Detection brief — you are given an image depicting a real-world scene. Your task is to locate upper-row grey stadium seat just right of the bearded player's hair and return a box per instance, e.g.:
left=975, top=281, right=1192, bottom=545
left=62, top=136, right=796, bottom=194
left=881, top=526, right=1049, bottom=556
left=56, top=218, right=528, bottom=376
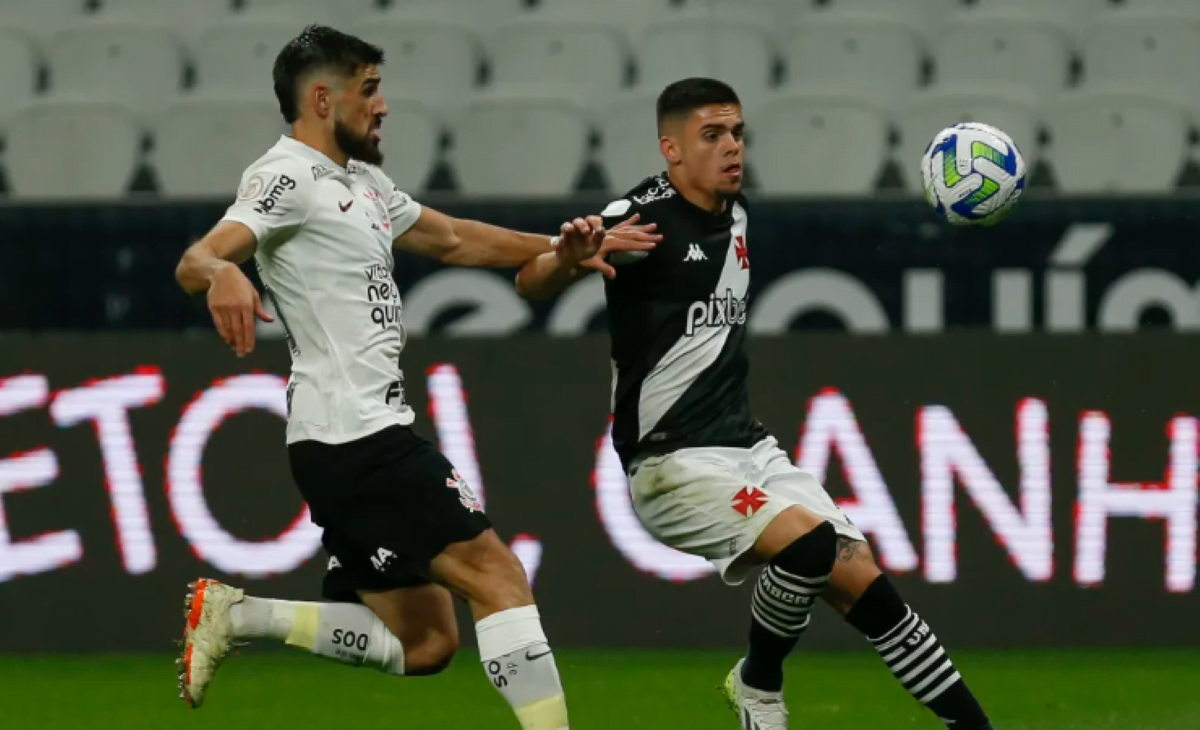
left=348, top=17, right=482, bottom=112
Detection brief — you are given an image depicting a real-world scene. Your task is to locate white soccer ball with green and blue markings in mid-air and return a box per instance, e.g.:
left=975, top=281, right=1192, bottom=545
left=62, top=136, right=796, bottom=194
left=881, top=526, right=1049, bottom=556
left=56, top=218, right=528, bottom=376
left=920, top=122, right=1025, bottom=226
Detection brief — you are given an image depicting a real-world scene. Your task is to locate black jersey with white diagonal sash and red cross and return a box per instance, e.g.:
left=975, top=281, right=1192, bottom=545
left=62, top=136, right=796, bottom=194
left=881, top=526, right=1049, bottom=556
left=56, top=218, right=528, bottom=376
left=602, top=174, right=767, bottom=469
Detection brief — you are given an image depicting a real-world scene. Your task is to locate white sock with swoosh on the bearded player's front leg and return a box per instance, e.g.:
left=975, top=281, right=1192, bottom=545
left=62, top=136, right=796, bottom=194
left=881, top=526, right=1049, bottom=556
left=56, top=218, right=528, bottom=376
left=475, top=606, right=569, bottom=730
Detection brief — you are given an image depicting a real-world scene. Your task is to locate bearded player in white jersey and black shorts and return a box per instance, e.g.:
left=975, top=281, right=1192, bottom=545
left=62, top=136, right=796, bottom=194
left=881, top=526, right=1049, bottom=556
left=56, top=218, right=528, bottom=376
left=169, top=26, right=655, bottom=730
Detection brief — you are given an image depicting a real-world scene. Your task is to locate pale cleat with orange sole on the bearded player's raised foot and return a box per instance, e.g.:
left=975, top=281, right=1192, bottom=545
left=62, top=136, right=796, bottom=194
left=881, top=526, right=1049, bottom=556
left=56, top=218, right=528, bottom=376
left=175, top=578, right=245, bottom=708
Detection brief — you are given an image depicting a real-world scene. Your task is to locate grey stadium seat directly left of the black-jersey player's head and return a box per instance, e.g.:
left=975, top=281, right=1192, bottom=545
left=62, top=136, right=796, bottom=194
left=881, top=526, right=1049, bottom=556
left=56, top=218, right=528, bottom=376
left=596, top=94, right=666, bottom=193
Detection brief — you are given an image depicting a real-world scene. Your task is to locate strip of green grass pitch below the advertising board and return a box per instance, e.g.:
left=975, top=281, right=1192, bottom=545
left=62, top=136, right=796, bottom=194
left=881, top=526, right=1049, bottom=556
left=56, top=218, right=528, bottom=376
left=0, top=650, right=1200, bottom=730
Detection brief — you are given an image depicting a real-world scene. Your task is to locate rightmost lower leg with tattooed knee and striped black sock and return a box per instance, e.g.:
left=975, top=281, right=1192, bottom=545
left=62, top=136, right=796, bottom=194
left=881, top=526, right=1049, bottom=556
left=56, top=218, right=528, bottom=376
left=827, top=540, right=991, bottom=730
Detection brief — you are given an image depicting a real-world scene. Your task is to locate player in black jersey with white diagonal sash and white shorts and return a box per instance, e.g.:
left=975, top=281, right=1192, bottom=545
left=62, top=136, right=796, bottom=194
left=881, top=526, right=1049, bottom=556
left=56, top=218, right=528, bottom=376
left=517, top=78, right=990, bottom=730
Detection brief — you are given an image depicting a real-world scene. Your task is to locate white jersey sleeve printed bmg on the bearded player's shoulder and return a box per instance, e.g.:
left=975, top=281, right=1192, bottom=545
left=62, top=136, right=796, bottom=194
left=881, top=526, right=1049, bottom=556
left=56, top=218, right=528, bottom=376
left=221, top=160, right=313, bottom=246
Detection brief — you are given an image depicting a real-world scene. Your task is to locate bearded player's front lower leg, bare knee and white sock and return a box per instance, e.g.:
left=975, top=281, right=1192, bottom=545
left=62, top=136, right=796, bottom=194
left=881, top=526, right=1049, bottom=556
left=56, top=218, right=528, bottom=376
left=432, top=529, right=569, bottom=730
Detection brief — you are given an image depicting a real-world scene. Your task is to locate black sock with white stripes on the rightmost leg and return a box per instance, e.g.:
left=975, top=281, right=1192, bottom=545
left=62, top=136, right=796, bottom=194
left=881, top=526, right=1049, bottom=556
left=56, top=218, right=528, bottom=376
left=846, top=575, right=990, bottom=730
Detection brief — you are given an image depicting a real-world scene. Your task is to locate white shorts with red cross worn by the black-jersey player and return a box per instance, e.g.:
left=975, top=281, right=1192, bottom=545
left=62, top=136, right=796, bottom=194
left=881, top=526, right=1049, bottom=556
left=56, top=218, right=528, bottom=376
left=630, top=437, right=865, bottom=585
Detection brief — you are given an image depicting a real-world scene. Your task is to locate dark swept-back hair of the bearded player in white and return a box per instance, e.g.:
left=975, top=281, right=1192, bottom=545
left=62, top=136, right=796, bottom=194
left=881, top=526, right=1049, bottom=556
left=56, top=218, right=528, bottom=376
left=271, top=25, right=384, bottom=124
